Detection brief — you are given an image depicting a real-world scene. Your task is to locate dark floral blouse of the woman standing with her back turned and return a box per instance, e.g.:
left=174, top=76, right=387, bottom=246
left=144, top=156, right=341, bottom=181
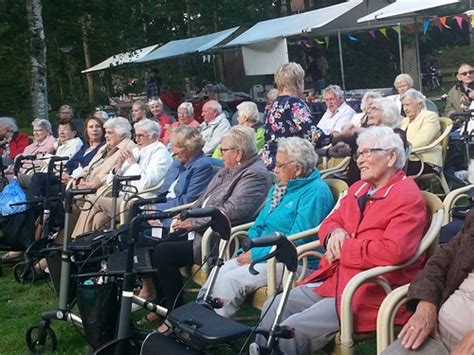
left=262, top=95, right=318, bottom=171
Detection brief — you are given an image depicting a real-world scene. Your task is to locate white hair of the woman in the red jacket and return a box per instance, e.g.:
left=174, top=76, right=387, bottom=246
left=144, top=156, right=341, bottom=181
left=357, top=126, right=406, bottom=170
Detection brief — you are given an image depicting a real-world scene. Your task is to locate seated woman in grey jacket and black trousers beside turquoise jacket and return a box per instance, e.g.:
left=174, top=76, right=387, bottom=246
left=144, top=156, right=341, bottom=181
left=152, top=126, right=272, bottom=310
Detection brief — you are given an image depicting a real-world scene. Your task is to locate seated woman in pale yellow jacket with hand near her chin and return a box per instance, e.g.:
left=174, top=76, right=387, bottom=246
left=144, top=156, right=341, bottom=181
left=401, top=89, right=443, bottom=175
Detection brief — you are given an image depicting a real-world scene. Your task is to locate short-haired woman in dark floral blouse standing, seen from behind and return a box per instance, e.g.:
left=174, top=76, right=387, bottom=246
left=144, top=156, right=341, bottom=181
left=262, top=62, right=316, bottom=171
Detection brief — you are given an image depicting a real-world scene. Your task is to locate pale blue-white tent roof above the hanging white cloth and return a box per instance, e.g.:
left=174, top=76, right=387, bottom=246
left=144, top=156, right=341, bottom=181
left=226, top=0, right=364, bottom=47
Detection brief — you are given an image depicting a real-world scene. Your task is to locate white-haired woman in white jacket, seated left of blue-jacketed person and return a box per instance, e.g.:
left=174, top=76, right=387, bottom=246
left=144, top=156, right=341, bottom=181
left=72, top=119, right=173, bottom=237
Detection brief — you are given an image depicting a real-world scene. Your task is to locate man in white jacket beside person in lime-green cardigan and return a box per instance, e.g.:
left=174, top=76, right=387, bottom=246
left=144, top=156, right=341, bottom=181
left=200, top=100, right=230, bottom=155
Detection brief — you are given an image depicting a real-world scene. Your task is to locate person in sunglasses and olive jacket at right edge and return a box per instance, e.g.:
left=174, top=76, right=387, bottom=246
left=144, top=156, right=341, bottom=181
left=444, top=63, right=474, bottom=117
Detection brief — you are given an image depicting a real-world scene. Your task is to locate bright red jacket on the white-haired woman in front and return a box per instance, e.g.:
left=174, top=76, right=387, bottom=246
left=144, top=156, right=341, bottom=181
left=303, top=171, right=429, bottom=332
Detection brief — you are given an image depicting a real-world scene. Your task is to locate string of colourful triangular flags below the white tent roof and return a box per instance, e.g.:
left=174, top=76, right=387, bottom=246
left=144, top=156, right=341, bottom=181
left=306, top=14, right=474, bottom=48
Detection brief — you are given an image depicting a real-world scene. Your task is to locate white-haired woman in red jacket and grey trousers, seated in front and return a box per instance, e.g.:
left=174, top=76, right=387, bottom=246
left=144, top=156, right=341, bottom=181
left=261, top=127, right=428, bottom=354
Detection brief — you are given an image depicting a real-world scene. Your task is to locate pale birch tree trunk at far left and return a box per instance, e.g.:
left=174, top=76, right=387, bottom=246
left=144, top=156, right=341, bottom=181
left=26, top=0, right=48, bottom=119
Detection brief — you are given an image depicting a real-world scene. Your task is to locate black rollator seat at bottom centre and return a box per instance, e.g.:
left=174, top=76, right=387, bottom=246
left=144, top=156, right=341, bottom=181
left=167, top=302, right=252, bottom=347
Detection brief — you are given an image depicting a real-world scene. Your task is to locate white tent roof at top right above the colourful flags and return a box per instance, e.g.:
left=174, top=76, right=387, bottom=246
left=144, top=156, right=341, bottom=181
left=357, top=0, right=462, bottom=23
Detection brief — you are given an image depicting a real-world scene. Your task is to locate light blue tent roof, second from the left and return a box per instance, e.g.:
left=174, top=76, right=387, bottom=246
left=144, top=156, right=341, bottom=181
left=135, top=27, right=239, bottom=63
